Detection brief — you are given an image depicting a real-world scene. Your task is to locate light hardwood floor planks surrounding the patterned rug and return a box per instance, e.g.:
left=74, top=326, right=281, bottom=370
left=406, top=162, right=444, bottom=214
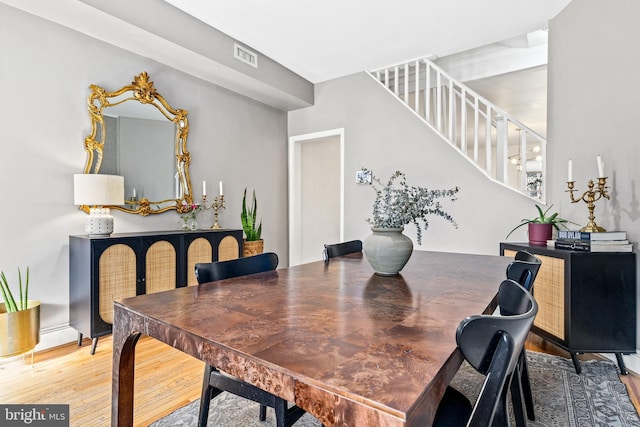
left=0, top=335, right=640, bottom=427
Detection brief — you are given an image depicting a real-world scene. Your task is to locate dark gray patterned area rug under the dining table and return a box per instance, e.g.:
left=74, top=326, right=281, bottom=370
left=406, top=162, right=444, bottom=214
left=152, top=351, right=640, bottom=427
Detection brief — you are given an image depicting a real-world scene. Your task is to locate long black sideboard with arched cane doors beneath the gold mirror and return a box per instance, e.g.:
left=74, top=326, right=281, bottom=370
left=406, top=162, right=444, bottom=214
left=69, top=230, right=242, bottom=354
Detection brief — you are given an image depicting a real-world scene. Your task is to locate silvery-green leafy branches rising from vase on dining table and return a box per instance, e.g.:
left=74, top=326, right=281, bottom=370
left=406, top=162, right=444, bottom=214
left=362, top=168, right=460, bottom=245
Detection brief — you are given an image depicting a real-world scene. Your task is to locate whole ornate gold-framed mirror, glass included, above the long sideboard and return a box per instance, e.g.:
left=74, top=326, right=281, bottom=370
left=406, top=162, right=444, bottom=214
left=83, top=72, right=192, bottom=216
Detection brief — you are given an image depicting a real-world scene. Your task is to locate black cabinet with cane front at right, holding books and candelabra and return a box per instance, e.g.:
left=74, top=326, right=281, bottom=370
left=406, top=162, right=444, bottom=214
left=500, top=243, right=636, bottom=373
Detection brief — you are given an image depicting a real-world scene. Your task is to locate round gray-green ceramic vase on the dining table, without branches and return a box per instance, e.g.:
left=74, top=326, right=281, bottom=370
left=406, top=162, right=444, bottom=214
left=362, top=227, right=413, bottom=276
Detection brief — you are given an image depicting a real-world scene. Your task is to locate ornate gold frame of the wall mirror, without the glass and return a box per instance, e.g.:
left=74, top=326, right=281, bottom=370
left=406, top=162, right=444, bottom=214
left=80, top=71, right=193, bottom=216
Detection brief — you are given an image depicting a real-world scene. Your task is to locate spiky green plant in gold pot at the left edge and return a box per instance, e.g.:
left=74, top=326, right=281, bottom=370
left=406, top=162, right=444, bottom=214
left=0, top=267, right=40, bottom=357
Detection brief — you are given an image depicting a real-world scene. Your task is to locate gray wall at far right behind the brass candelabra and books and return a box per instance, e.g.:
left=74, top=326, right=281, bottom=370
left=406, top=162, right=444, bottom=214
left=548, top=0, right=640, bottom=348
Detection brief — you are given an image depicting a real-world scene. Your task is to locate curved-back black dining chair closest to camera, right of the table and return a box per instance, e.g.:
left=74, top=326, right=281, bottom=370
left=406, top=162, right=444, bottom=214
left=433, top=279, right=538, bottom=427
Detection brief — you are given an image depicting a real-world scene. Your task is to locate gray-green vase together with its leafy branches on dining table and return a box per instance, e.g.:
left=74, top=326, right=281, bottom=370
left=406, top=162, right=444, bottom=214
left=362, top=168, right=459, bottom=276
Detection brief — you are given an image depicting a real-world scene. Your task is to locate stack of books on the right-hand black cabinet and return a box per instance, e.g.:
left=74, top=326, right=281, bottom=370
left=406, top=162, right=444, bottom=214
left=555, top=230, right=633, bottom=252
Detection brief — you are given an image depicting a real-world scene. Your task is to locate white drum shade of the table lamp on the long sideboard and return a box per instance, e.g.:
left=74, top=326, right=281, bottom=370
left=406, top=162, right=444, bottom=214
left=73, top=173, right=124, bottom=206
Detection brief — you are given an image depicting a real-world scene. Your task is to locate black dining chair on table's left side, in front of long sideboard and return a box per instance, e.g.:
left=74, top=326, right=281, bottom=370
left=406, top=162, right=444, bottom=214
left=195, top=252, right=305, bottom=427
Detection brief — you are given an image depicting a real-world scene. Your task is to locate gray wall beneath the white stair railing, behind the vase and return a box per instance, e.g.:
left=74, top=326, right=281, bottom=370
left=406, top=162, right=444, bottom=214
left=289, top=73, right=535, bottom=254
